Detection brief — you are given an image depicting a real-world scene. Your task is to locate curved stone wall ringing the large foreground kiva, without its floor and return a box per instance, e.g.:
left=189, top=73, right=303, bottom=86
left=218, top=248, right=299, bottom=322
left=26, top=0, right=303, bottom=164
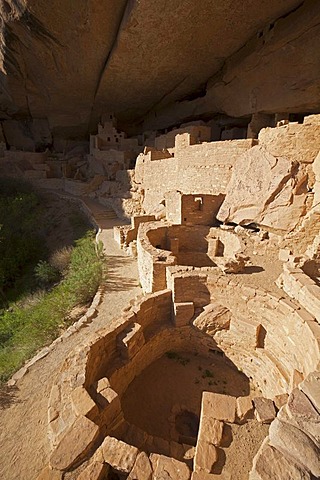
left=47, top=276, right=320, bottom=479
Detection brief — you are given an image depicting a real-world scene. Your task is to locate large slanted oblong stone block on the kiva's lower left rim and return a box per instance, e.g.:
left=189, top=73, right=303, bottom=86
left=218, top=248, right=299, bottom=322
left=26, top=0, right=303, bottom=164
left=50, top=416, right=99, bottom=471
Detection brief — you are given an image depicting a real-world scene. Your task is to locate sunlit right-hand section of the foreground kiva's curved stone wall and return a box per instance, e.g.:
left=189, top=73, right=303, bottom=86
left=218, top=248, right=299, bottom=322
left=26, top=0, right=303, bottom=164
left=167, top=267, right=320, bottom=398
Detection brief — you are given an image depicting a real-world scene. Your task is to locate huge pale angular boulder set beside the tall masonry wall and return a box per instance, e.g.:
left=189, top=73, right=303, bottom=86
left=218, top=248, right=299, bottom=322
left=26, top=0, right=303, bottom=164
left=217, top=146, right=306, bottom=231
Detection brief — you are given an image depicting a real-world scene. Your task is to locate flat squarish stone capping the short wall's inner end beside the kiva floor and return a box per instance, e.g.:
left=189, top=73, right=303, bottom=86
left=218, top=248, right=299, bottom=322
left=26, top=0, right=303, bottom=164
left=201, top=392, right=236, bottom=423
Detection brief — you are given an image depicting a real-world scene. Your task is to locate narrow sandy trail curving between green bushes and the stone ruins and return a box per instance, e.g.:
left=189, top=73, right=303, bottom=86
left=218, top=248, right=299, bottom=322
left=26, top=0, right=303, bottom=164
left=0, top=198, right=142, bottom=480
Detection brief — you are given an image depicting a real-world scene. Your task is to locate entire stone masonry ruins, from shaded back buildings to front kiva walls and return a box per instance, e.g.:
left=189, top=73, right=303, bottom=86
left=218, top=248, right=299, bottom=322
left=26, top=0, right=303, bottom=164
left=15, top=115, right=320, bottom=480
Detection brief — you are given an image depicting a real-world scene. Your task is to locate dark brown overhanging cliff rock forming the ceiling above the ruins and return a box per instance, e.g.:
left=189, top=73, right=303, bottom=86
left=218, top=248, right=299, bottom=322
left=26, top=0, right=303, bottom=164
left=0, top=0, right=320, bottom=144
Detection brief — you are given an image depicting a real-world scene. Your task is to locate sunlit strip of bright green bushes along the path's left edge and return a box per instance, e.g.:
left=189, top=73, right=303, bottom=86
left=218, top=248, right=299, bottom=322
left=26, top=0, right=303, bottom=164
left=0, top=232, right=102, bottom=381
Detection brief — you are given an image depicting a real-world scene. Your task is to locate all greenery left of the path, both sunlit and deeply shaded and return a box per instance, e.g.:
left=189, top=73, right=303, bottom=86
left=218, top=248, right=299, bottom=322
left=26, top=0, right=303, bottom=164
left=0, top=178, right=102, bottom=382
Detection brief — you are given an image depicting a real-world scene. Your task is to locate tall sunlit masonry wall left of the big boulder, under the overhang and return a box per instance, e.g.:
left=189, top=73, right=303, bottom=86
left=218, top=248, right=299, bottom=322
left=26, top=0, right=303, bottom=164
left=135, top=139, right=253, bottom=213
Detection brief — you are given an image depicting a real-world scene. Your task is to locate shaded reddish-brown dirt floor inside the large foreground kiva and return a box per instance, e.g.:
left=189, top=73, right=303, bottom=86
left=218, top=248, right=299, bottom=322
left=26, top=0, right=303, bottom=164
left=122, top=352, right=254, bottom=440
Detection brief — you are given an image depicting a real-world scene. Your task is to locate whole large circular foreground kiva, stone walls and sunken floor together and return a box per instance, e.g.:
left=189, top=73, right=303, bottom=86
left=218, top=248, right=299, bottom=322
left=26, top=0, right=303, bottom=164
left=48, top=267, right=320, bottom=480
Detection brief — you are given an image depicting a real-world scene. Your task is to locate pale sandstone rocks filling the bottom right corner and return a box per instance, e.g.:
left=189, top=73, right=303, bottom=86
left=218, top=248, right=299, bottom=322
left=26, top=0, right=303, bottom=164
left=249, top=371, right=320, bottom=480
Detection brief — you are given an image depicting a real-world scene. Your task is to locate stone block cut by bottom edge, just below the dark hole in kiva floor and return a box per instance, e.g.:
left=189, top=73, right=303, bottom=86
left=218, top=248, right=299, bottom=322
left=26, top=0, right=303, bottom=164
left=149, top=453, right=191, bottom=480
